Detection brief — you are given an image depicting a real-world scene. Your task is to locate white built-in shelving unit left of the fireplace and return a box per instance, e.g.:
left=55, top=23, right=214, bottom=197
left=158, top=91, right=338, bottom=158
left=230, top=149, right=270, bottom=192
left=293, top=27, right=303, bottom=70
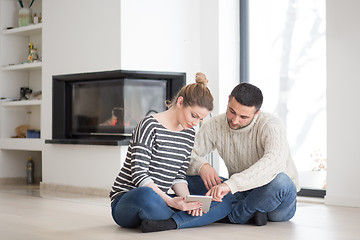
left=0, top=0, right=44, bottom=178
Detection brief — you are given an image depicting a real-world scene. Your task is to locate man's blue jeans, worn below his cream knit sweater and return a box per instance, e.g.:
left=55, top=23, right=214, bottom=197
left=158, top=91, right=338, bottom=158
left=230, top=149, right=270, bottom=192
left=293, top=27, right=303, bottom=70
left=187, top=173, right=297, bottom=224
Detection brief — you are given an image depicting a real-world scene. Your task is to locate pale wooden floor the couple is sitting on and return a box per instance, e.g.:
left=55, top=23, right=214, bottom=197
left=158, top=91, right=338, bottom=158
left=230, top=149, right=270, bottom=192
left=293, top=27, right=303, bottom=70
left=0, top=186, right=360, bottom=240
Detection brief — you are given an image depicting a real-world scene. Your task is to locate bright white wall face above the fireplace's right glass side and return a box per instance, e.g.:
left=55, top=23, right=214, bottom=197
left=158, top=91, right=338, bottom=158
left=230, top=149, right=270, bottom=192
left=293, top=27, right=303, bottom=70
left=121, top=0, right=201, bottom=75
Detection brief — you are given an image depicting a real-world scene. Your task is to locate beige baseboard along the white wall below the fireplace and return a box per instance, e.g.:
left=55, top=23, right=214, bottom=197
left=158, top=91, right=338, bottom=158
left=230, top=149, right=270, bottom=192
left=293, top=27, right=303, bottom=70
left=40, top=182, right=110, bottom=197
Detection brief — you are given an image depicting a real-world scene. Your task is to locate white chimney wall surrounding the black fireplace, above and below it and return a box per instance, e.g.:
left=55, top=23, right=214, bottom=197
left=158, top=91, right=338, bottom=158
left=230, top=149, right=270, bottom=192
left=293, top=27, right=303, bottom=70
left=42, top=0, right=238, bottom=189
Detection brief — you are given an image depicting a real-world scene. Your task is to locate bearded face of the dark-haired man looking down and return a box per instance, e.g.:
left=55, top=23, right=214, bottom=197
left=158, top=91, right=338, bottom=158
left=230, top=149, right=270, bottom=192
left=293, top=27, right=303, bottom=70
left=226, top=97, right=260, bottom=130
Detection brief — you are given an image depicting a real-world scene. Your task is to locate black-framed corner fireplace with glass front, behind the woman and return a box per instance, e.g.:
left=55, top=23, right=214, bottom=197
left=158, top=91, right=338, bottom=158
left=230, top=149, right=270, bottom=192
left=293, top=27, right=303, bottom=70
left=45, top=70, right=186, bottom=145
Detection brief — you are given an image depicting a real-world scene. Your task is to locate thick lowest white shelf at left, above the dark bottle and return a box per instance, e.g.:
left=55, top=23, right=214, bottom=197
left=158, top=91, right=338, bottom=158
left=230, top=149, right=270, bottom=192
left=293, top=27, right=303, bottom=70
left=0, top=138, right=44, bottom=151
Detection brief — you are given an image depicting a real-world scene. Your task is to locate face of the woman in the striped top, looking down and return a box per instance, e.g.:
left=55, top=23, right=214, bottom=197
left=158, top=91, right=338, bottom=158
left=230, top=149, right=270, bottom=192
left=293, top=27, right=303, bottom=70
left=178, top=96, right=210, bottom=129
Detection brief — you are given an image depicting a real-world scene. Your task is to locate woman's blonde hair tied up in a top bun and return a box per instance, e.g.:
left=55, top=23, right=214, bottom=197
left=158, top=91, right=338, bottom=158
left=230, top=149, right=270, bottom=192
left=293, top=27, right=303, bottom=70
left=167, top=72, right=214, bottom=111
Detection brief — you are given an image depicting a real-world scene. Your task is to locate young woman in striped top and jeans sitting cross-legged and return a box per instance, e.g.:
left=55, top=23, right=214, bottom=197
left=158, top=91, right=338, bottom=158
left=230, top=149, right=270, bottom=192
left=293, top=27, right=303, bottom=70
left=110, top=73, right=231, bottom=232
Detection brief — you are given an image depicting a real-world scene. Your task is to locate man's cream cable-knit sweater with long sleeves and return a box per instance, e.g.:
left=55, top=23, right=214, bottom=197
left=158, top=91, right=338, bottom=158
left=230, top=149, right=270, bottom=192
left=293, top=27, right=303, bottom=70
left=188, top=112, right=300, bottom=193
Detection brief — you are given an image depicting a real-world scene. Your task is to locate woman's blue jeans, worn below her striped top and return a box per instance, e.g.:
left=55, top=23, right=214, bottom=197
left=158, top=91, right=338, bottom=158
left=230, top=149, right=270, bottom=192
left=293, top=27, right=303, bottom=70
left=111, top=187, right=235, bottom=229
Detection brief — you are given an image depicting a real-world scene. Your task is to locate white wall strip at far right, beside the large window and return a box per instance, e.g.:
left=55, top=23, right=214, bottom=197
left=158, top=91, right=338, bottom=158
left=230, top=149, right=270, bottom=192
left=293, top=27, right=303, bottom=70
left=326, top=0, right=360, bottom=207
